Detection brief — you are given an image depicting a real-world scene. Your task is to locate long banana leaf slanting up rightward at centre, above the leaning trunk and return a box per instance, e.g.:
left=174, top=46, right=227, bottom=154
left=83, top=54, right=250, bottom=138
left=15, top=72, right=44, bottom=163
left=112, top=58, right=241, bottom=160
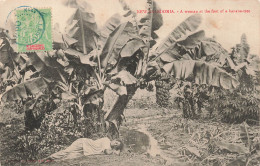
left=100, top=22, right=138, bottom=70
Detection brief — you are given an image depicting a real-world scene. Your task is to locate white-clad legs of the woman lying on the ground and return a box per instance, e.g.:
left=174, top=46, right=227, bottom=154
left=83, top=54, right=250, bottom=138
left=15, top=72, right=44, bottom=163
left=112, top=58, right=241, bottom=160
left=49, top=138, right=84, bottom=160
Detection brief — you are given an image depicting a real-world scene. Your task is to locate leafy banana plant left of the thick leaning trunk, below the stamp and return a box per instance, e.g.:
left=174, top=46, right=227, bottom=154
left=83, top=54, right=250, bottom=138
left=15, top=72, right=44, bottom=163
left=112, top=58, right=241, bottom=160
left=1, top=0, right=145, bottom=134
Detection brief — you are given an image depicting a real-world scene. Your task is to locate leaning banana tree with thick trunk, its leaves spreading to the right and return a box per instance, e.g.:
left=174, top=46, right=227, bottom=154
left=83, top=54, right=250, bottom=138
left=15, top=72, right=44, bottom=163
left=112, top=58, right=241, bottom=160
left=102, top=0, right=239, bottom=136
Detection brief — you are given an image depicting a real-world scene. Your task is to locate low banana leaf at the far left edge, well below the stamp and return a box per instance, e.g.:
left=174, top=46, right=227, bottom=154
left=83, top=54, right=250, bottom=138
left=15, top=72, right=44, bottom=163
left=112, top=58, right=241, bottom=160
left=1, top=77, right=49, bottom=102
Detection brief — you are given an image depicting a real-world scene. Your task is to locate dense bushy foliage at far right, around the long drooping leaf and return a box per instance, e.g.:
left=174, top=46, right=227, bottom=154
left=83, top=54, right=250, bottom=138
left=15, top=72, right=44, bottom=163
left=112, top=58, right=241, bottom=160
left=157, top=34, right=260, bottom=124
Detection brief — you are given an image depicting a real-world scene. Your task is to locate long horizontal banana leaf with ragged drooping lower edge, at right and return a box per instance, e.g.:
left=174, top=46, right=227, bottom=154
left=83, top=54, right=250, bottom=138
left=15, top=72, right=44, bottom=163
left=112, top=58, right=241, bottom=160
left=163, top=60, right=239, bottom=89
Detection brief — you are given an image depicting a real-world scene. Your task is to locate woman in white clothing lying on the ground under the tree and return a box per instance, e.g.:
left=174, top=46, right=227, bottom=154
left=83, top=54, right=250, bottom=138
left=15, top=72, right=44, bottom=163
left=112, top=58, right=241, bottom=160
left=43, top=137, right=123, bottom=162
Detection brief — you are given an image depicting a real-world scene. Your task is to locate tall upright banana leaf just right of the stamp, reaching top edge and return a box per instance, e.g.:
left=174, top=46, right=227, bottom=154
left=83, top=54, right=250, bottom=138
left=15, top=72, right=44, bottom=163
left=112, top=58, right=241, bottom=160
left=65, top=0, right=98, bottom=54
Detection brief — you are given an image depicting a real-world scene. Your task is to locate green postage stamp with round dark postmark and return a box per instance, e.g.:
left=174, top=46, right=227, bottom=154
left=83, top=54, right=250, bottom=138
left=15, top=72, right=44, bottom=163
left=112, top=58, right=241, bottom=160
left=16, top=8, right=52, bottom=52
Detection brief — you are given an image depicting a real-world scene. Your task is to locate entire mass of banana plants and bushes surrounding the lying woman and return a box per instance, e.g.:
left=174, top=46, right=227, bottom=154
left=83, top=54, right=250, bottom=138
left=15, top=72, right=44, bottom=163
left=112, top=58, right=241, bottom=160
left=0, top=0, right=259, bottom=164
